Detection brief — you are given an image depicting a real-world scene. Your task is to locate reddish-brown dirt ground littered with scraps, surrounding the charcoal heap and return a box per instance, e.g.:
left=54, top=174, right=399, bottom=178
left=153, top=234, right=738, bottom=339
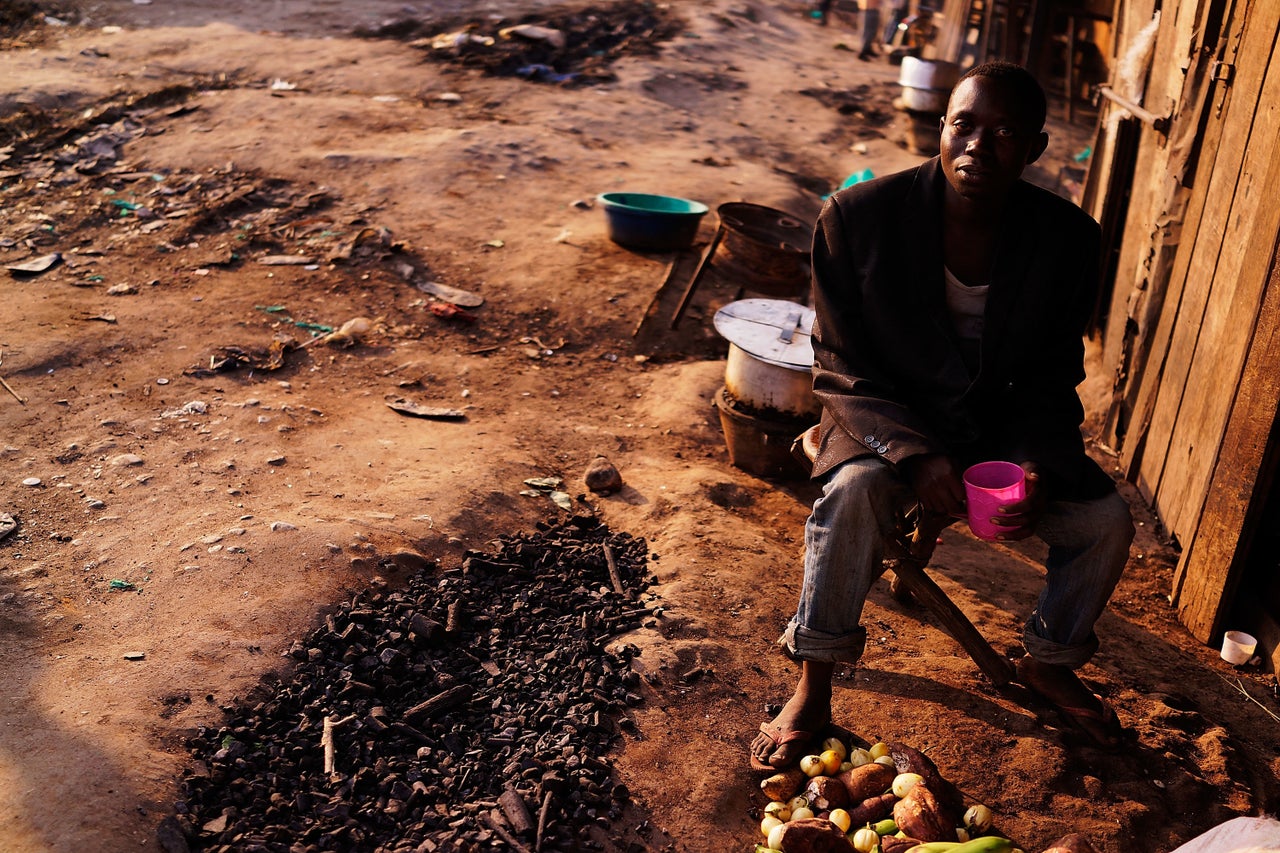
left=0, top=0, right=1280, bottom=852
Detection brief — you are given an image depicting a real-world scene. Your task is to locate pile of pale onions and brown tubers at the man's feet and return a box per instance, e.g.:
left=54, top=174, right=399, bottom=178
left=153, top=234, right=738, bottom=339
left=754, top=736, right=1094, bottom=853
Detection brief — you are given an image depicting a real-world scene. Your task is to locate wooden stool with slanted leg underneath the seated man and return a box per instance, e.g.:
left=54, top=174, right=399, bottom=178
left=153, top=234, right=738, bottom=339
left=792, top=427, right=1014, bottom=686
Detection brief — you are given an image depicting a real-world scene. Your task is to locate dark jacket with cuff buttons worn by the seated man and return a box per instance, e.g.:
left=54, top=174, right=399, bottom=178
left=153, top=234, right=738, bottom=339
left=813, top=158, right=1114, bottom=500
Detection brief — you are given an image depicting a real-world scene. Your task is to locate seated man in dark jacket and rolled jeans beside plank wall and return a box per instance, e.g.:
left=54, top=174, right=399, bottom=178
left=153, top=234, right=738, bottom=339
left=751, top=63, right=1134, bottom=768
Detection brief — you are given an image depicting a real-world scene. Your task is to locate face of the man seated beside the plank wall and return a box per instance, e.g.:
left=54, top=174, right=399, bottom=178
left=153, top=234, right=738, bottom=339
left=941, top=77, right=1048, bottom=201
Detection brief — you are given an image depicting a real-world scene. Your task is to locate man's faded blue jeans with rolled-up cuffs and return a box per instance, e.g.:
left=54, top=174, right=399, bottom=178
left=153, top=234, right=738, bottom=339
left=781, top=457, right=1134, bottom=669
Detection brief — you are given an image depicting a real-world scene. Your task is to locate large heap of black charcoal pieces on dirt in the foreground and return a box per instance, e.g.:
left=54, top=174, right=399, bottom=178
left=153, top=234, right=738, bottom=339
left=177, top=517, right=660, bottom=853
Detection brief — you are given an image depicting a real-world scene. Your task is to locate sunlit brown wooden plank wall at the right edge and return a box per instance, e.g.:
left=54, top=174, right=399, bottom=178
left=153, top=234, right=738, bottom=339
left=1087, top=0, right=1280, bottom=642
